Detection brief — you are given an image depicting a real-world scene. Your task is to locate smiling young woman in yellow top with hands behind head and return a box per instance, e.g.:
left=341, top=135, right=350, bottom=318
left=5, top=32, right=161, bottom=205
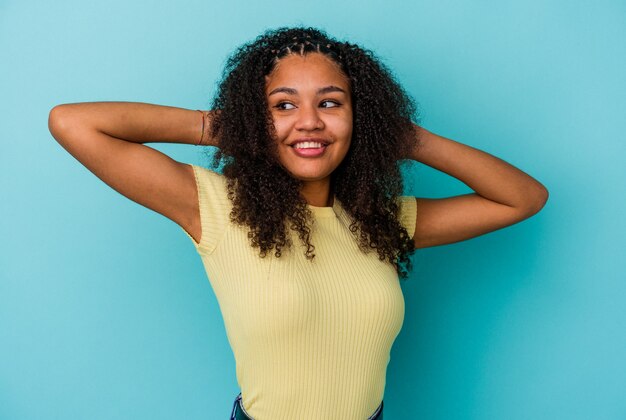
left=49, top=28, right=548, bottom=420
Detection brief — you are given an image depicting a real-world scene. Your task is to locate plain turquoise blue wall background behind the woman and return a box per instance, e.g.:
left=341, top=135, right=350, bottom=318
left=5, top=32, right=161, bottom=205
left=0, top=0, right=626, bottom=420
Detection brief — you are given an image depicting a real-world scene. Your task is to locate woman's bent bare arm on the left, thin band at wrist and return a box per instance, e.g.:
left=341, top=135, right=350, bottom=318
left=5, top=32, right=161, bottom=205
left=48, top=102, right=215, bottom=242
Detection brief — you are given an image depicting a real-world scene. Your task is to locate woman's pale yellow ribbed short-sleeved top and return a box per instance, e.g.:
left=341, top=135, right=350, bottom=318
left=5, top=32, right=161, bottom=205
left=183, top=165, right=416, bottom=420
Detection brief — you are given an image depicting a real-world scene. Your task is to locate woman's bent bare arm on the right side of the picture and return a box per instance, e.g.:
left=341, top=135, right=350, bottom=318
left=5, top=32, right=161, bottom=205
left=409, top=126, right=548, bottom=248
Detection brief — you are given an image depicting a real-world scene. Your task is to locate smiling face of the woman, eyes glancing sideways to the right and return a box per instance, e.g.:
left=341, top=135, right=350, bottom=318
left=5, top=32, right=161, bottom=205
left=265, top=53, right=352, bottom=184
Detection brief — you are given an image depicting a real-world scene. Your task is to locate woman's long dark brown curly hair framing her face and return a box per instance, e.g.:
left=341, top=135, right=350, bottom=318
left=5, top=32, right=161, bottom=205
left=206, top=27, right=417, bottom=278
